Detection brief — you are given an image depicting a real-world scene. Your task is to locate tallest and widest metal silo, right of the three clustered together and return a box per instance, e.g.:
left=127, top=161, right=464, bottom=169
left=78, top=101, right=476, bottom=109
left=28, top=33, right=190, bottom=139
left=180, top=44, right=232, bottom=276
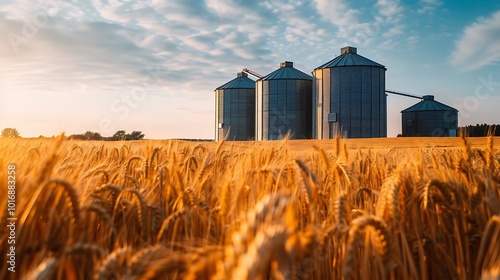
left=313, top=47, right=387, bottom=139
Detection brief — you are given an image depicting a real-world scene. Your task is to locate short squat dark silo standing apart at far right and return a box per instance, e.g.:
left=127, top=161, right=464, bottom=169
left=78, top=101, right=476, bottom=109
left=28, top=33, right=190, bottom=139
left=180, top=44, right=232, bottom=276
left=401, top=95, right=458, bottom=137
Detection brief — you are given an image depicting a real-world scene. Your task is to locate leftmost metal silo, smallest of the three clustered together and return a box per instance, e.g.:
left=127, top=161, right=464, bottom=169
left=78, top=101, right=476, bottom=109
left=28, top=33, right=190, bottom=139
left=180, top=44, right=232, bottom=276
left=215, top=72, right=255, bottom=141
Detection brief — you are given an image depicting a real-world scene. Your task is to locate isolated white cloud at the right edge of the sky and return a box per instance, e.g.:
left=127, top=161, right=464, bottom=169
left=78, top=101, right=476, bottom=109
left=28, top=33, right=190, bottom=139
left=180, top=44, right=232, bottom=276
left=451, top=11, right=500, bottom=71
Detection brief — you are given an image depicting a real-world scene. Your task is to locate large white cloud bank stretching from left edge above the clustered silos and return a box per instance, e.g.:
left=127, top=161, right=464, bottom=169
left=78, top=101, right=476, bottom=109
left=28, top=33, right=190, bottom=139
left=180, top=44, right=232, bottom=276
left=0, top=0, right=410, bottom=101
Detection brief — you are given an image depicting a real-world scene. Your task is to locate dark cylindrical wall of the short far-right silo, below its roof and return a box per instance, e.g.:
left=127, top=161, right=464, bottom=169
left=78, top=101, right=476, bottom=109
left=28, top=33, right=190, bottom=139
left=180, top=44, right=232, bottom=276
left=402, top=111, right=458, bottom=137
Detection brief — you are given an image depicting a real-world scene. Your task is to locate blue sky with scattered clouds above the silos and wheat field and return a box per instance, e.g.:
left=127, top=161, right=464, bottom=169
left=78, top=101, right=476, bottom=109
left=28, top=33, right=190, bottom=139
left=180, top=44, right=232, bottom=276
left=0, top=0, right=500, bottom=139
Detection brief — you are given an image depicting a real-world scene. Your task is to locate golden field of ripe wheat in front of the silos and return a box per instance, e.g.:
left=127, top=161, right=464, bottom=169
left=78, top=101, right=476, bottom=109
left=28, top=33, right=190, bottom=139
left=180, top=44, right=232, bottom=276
left=0, top=137, right=500, bottom=280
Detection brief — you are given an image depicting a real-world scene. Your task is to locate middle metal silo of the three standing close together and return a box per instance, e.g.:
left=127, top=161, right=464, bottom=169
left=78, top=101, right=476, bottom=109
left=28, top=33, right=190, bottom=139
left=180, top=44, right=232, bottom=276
left=256, top=61, right=312, bottom=140
